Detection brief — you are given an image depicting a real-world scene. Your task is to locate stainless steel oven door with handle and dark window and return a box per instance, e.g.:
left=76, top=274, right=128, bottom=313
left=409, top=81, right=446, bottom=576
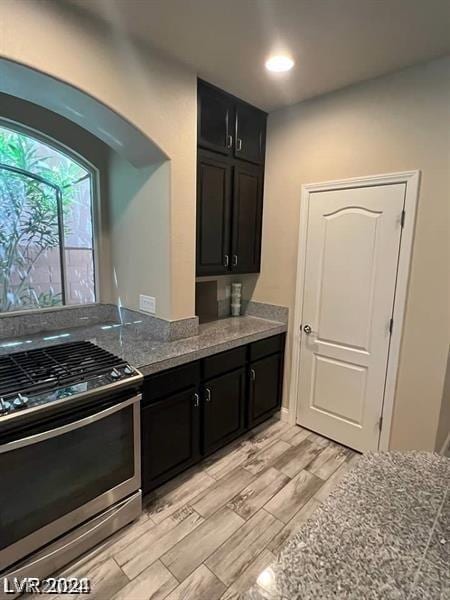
left=0, top=394, right=141, bottom=571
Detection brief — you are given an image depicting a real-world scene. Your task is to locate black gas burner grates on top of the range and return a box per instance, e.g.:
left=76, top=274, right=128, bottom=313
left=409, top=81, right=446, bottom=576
left=0, top=342, right=126, bottom=398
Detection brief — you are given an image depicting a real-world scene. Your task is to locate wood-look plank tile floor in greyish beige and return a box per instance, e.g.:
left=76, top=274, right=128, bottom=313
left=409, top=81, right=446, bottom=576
left=33, top=419, right=359, bottom=600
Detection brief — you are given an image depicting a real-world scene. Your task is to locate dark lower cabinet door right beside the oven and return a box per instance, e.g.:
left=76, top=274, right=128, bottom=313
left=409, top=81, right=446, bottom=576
left=141, top=386, right=200, bottom=493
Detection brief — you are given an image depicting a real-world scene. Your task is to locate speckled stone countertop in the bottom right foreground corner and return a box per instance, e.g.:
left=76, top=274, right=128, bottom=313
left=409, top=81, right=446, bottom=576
left=241, top=452, right=450, bottom=600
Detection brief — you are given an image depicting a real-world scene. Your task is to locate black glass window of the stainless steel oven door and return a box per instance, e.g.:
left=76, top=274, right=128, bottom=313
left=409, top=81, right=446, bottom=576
left=0, top=405, right=134, bottom=549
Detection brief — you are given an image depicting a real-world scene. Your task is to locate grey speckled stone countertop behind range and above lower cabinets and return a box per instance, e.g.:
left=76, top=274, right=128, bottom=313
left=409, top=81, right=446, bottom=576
left=0, top=316, right=286, bottom=375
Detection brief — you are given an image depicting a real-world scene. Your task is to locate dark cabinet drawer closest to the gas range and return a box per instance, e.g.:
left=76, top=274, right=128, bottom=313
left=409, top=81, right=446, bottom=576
left=142, top=361, right=200, bottom=404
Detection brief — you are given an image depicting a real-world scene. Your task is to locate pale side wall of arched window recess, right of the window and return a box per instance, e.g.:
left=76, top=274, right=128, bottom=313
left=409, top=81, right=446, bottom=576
left=108, top=152, right=171, bottom=319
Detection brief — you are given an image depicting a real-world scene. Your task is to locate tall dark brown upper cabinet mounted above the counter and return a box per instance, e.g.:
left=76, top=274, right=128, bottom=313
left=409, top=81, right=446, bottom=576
left=197, top=80, right=267, bottom=275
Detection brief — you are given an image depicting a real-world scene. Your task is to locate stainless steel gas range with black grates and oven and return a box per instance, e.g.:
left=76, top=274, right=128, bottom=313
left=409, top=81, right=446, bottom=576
left=0, top=342, right=142, bottom=578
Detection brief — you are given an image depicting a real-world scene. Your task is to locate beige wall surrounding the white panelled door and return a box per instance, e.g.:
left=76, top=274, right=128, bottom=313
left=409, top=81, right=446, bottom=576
left=253, top=58, right=450, bottom=450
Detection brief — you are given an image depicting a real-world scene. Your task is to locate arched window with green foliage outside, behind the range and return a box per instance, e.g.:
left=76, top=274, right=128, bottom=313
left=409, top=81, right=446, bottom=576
left=0, top=122, right=95, bottom=312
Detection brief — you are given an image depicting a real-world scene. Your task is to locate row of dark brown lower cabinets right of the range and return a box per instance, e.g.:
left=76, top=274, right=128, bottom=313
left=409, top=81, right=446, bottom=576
left=141, top=334, right=285, bottom=493
